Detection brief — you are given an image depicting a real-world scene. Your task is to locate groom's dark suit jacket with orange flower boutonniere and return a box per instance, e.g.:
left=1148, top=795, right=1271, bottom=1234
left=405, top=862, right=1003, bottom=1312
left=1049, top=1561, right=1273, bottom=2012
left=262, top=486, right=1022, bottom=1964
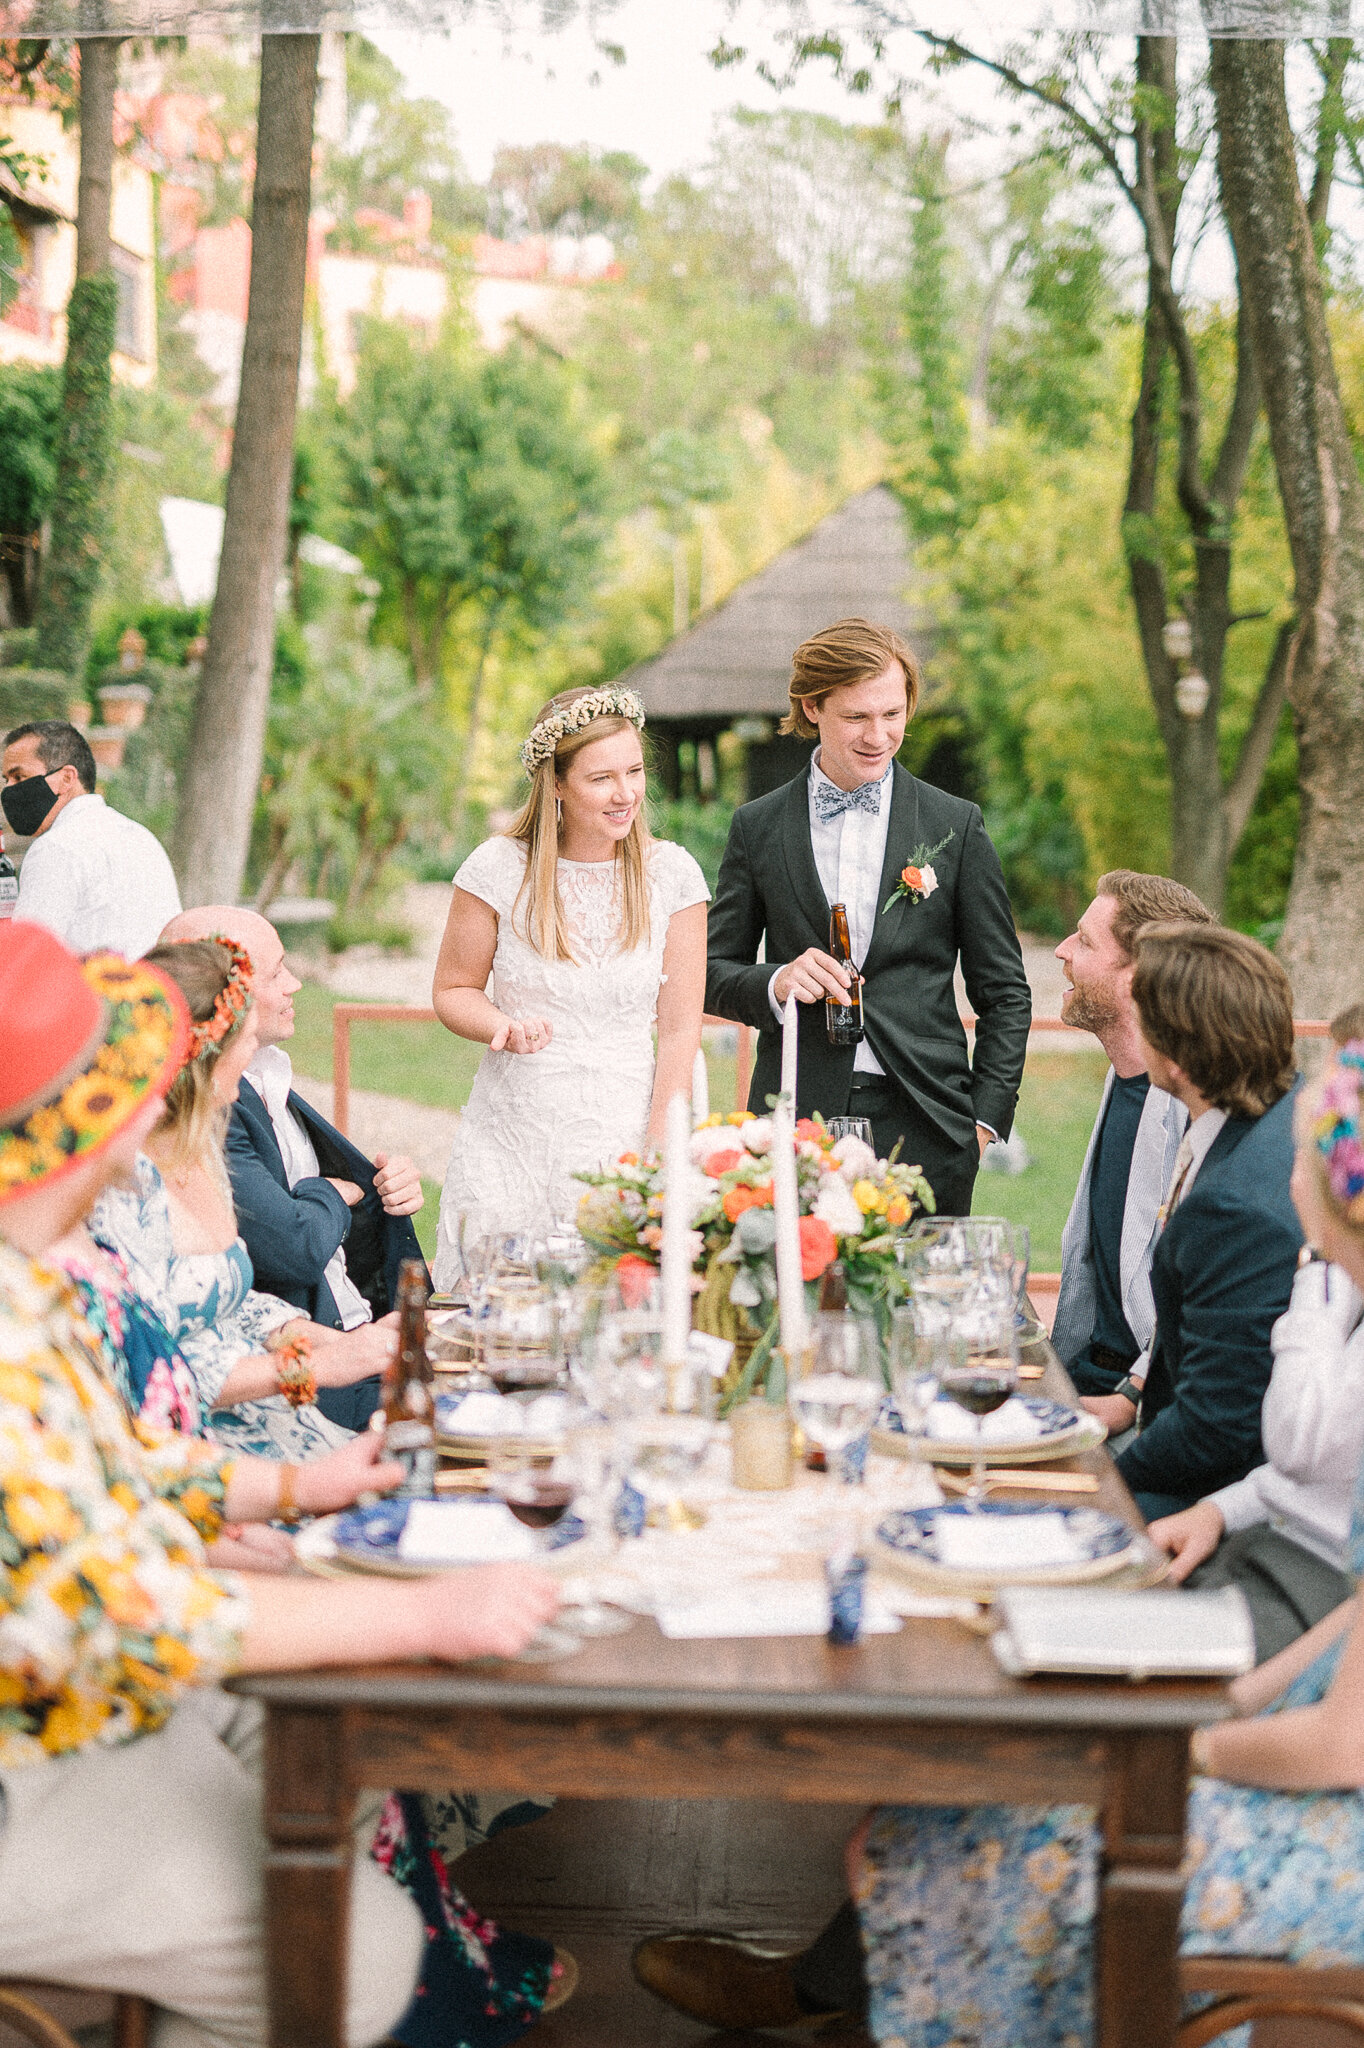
left=707, top=762, right=1032, bottom=1151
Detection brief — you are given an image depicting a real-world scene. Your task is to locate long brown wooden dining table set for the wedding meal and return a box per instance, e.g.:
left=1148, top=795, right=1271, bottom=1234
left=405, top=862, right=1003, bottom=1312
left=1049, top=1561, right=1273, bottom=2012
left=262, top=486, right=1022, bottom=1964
left=231, top=1346, right=1231, bottom=2048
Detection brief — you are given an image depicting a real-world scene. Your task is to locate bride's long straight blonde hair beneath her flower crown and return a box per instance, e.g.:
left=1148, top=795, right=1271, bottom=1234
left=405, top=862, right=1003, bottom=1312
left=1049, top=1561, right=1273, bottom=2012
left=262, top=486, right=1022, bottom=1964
left=508, top=688, right=649, bottom=961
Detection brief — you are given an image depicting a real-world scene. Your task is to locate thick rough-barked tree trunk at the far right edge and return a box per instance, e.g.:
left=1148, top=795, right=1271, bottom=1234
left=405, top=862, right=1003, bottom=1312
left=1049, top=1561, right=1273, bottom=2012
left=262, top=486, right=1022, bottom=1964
left=1212, top=41, right=1364, bottom=1018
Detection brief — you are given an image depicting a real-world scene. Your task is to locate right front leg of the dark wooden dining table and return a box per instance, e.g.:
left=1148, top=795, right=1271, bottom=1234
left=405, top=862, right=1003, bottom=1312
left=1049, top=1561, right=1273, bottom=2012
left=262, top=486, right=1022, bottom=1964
left=1096, top=1731, right=1188, bottom=2048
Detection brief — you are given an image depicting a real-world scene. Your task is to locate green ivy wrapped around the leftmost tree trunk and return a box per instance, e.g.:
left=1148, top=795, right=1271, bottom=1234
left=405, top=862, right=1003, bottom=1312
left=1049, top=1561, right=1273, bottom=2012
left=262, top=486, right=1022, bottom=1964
left=35, top=270, right=119, bottom=678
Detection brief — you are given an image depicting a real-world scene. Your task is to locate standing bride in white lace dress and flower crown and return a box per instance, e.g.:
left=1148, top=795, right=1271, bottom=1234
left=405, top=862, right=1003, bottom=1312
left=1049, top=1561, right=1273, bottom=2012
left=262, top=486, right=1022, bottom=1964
left=432, top=688, right=709, bottom=1288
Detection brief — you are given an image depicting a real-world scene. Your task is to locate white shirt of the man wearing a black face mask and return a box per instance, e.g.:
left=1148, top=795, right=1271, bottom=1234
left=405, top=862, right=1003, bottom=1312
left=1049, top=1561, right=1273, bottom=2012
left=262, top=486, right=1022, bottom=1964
left=14, top=795, right=180, bottom=961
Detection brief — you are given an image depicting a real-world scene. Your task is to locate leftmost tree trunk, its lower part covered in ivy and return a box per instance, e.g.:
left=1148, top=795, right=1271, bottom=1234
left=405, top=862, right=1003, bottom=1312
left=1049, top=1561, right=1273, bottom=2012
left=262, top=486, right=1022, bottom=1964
left=35, top=37, right=119, bottom=682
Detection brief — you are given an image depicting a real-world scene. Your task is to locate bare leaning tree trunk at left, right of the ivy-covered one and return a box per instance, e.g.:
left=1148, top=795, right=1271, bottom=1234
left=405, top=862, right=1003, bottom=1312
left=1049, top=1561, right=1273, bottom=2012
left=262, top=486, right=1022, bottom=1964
left=176, top=35, right=319, bottom=905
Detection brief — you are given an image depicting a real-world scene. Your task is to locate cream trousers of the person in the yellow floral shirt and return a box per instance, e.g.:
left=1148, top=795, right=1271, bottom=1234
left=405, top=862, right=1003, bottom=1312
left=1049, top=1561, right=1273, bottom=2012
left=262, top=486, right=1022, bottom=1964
left=0, top=1692, right=424, bottom=2048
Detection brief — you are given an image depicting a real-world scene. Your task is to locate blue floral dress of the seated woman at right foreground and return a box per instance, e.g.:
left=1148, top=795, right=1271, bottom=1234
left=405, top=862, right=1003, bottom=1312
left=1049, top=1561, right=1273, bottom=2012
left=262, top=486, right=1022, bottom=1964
left=856, top=1473, right=1364, bottom=2048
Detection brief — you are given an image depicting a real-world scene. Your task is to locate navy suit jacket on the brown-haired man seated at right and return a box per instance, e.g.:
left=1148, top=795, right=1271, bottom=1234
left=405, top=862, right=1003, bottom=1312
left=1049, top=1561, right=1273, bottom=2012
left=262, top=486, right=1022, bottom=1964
left=1118, top=1087, right=1303, bottom=1505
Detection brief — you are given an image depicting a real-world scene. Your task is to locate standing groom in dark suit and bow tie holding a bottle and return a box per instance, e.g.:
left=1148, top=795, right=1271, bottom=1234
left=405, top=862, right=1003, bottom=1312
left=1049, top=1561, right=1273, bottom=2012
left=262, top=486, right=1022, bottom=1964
left=707, top=618, right=1032, bottom=1214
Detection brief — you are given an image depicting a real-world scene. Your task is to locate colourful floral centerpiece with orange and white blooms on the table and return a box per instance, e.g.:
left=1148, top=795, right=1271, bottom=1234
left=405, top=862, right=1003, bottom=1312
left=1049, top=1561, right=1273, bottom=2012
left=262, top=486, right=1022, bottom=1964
left=578, top=1110, right=936, bottom=1407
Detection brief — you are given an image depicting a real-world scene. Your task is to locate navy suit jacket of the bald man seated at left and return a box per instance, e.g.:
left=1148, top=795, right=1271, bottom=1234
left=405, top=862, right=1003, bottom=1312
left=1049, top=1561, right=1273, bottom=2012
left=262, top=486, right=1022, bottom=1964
left=227, top=1081, right=422, bottom=1430
